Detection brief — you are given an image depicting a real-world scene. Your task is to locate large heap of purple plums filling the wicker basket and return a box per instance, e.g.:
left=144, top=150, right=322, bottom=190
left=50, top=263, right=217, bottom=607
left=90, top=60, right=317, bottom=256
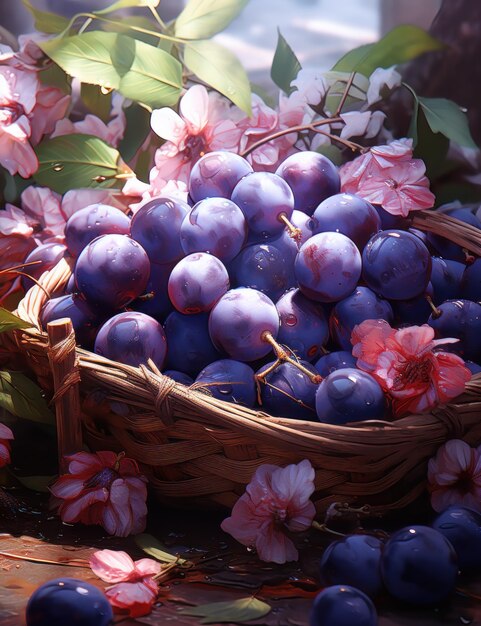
left=33, top=151, right=481, bottom=424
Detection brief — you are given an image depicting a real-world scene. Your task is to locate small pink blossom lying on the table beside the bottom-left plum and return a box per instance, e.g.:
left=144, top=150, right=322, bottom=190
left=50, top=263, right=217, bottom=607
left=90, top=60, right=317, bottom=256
left=90, top=550, right=161, bottom=618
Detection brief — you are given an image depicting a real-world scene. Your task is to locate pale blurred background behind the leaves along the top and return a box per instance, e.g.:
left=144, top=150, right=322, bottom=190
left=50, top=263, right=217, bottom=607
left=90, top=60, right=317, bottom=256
left=0, top=0, right=441, bottom=87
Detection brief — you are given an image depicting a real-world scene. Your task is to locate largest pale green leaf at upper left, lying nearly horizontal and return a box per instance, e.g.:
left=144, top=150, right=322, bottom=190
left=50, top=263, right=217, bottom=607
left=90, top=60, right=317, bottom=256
left=39, top=31, right=182, bottom=108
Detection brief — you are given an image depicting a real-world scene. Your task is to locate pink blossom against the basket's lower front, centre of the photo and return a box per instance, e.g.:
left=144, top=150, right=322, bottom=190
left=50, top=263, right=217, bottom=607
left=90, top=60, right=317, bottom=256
left=221, top=460, right=315, bottom=563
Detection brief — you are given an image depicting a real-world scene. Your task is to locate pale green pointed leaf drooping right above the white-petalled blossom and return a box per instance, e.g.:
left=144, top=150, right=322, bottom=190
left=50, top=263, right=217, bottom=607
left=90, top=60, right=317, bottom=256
left=184, top=40, right=252, bottom=115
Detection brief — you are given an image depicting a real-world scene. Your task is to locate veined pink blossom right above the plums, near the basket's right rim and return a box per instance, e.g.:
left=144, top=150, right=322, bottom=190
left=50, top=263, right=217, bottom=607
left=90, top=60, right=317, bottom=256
left=339, top=139, right=434, bottom=217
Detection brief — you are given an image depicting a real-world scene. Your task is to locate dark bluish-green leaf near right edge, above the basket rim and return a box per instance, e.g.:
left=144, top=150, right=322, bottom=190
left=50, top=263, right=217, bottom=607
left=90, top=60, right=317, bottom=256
left=418, top=96, right=476, bottom=148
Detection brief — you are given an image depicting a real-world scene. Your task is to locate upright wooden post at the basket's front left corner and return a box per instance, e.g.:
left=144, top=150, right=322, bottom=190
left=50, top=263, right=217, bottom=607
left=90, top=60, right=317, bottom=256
left=47, top=318, right=82, bottom=473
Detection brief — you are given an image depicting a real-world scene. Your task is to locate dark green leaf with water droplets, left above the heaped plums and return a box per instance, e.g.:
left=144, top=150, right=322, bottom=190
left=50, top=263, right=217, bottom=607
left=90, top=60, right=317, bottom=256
left=34, top=134, right=126, bottom=193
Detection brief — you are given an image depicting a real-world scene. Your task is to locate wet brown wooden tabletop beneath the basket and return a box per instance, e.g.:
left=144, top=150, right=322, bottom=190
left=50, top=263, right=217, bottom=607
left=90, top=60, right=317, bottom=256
left=0, top=489, right=481, bottom=626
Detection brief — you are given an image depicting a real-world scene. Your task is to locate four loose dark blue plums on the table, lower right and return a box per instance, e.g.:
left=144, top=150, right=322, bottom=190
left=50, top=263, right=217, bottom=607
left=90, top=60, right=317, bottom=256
left=310, top=505, right=481, bottom=626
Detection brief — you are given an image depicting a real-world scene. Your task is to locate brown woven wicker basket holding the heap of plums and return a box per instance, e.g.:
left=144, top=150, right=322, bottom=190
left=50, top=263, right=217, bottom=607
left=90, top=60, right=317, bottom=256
left=2, top=211, right=481, bottom=514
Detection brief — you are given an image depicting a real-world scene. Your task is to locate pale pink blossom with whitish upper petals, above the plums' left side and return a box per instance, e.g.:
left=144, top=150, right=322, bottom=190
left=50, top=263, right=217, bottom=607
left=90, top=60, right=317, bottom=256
left=150, top=85, right=242, bottom=190
